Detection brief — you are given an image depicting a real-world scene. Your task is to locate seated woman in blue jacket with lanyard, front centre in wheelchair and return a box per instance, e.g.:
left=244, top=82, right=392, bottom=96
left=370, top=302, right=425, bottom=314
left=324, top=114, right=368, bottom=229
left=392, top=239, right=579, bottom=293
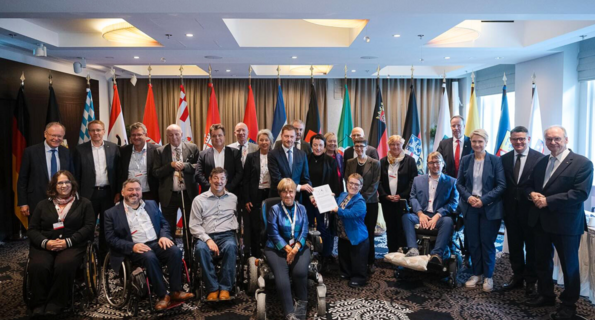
left=264, top=178, right=310, bottom=320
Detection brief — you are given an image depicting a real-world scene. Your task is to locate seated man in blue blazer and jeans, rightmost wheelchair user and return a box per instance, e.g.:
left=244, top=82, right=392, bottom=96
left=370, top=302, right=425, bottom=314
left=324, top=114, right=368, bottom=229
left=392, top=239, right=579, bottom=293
left=403, top=152, right=459, bottom=265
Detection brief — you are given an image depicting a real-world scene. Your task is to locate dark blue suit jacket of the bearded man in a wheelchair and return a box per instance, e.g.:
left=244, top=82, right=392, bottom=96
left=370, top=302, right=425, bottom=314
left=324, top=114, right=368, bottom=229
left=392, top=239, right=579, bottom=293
left=104, top=200, right=173, bottom=272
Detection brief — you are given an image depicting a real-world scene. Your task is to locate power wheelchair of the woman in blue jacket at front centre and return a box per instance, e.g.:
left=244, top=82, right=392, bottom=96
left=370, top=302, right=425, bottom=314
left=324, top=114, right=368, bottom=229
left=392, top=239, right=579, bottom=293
left=247, top=197, right=326, bottom=320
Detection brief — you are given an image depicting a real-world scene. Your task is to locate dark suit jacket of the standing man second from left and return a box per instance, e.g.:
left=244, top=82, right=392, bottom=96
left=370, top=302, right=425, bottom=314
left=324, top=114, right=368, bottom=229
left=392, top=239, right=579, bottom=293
left=73, top=141, right=122, bottom=199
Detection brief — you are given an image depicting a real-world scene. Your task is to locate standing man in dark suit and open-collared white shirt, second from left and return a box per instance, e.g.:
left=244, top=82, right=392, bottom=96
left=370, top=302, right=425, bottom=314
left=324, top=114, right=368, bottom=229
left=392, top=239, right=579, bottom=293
left=74, top=120, right=120, bottom=262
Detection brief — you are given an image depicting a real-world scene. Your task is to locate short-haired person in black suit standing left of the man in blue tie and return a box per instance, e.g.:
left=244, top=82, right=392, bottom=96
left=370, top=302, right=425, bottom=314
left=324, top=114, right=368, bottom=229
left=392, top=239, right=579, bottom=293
left=243, top=129, right=273, bottom=258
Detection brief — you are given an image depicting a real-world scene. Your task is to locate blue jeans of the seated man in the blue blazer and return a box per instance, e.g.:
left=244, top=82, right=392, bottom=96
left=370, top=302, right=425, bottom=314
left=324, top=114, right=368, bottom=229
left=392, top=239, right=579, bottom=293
left=402, top=212, right=453, bottom=258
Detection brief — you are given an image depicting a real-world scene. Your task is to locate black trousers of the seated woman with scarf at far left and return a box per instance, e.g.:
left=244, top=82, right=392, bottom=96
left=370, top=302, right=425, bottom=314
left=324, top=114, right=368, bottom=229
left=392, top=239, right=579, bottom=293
left=28, top=246, right=86, bottom=308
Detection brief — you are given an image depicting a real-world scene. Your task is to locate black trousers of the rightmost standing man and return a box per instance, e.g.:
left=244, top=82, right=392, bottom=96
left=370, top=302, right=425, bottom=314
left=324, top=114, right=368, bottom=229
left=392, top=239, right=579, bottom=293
left=534, top=223, right=581, bottom=309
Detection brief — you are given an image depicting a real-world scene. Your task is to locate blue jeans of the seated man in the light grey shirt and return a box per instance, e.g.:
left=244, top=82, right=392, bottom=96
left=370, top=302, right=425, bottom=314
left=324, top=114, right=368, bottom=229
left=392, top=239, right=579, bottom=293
left=194, top=230, right=238, bottom=292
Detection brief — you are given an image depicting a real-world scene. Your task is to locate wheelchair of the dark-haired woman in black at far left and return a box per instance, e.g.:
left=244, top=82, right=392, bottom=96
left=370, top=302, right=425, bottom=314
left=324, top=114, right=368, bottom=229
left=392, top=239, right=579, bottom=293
left=23, top=241, right=99, bottom=313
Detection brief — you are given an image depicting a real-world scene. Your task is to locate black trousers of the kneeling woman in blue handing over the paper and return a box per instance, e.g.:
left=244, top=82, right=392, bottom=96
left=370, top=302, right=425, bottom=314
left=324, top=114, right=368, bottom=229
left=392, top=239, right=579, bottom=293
left=338, top=238, right=370, bottom=285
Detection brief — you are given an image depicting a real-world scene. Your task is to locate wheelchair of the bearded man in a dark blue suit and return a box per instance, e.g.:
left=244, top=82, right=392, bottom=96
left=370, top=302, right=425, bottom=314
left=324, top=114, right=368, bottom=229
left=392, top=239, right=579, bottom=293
left=101, top=251, right=191, bottom=317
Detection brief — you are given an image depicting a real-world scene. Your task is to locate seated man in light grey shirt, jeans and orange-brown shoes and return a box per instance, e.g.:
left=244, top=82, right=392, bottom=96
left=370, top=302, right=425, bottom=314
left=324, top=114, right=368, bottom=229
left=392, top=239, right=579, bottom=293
left=189, top=167, right=238, bottom=301
